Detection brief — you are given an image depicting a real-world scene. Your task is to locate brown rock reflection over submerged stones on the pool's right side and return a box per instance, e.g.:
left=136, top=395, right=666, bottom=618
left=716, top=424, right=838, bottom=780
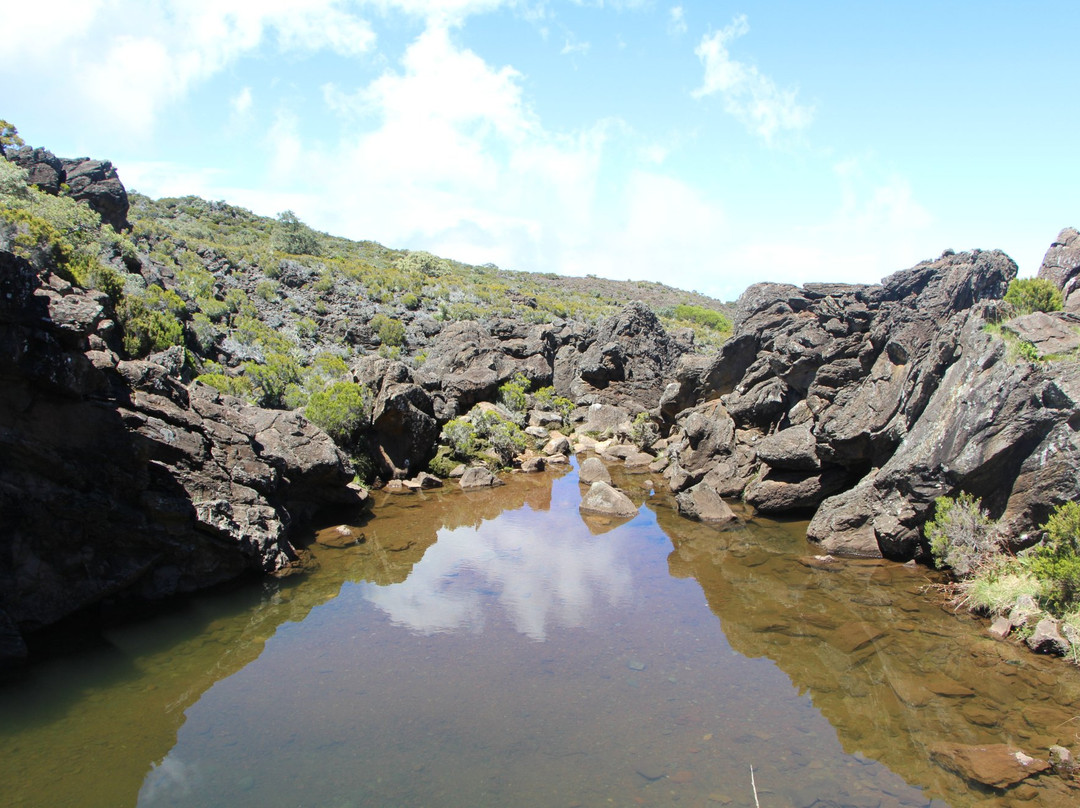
left=654, top=494, right=1080, bottom=806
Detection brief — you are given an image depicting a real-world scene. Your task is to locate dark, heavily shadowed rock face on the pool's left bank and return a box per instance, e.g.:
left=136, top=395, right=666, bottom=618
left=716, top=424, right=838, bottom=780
left=0, top=252, right=355, bottom=661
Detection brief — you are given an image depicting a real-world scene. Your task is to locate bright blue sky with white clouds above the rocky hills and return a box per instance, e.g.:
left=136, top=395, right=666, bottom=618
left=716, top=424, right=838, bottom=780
left=0, top=0, right=1080, bottom=300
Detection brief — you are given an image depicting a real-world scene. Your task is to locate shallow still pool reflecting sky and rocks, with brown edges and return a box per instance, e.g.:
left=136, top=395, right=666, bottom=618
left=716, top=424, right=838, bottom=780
left=0, top=458, right=1080, bottom=808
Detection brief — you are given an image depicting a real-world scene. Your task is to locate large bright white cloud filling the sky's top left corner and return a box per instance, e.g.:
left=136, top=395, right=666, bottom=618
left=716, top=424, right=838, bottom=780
left=0, top=0, right=375, bottom=135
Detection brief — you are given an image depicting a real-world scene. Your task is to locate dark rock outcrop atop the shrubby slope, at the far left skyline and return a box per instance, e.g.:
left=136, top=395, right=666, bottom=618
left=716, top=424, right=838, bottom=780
left=5, top=146, right=131, bottom=232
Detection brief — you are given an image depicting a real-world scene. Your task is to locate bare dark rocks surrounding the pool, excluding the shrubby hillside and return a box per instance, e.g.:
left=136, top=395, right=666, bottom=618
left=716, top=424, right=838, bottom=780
left=0, top=140, right=1080, bottom=660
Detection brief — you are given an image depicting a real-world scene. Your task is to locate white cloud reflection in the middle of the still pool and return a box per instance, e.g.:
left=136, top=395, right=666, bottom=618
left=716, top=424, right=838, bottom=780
left=360, top=507, right=632, bottom=641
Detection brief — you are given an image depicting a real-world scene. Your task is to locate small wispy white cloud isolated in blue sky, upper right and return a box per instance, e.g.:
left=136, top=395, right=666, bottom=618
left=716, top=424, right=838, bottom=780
left=693, top=14, right=813, bottom=143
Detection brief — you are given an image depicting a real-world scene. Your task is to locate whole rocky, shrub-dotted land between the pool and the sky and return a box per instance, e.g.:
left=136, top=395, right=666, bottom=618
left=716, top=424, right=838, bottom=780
left=0, top=139, right=1080, bottom=658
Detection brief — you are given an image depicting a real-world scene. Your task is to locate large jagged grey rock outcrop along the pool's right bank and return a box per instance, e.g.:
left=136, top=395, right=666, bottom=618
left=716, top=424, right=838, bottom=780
left=661, top=246, right=1080, bottom=558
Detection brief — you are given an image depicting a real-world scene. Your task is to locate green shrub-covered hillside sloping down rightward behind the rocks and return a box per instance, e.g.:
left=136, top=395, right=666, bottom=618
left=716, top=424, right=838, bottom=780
left=129, top=193, right=730, bottom=359
